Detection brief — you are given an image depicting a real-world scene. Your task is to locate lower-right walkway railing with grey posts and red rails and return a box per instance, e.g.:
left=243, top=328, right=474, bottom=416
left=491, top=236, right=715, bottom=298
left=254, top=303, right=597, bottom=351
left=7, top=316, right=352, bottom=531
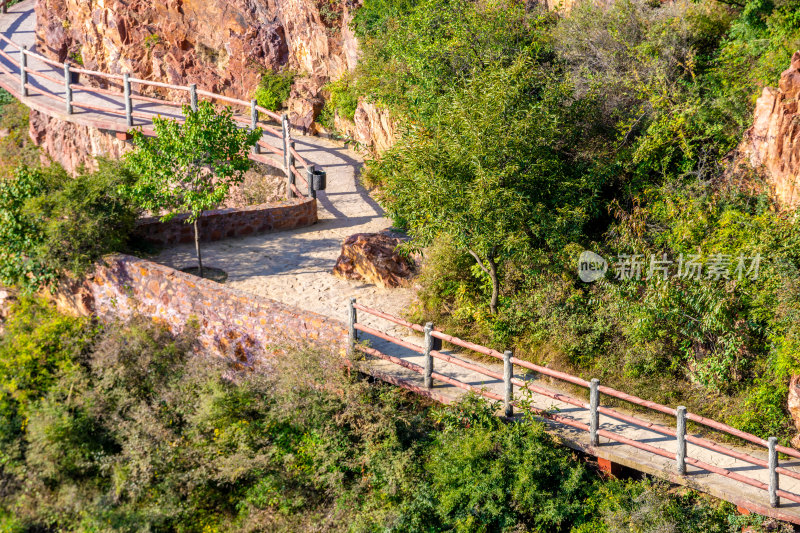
left=348, top=298, right=800, bottom=507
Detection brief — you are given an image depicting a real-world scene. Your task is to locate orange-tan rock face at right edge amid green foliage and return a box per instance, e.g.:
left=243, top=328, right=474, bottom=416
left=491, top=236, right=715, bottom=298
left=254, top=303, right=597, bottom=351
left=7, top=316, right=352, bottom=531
left=739, top=52, right=800, bottom=209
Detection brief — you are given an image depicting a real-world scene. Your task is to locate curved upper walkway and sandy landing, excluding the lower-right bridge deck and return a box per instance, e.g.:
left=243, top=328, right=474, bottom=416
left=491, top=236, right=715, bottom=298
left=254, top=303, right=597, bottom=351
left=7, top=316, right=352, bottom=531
left=0, top=0, right=411, bottom=332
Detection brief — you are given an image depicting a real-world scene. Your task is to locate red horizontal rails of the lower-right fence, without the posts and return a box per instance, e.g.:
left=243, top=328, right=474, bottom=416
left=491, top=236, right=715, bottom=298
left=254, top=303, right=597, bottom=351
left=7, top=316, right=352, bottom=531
left=351, top=301, right=800, bottom=503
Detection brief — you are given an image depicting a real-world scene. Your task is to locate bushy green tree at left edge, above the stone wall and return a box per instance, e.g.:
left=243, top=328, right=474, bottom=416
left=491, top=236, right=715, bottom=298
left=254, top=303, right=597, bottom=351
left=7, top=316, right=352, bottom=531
left=0, top=161, right=137, bottom=290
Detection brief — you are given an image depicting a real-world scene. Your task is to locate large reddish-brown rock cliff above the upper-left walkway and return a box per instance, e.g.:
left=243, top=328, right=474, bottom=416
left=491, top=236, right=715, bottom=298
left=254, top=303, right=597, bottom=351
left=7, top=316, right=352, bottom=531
left=36, top=0, right=357, bottom=111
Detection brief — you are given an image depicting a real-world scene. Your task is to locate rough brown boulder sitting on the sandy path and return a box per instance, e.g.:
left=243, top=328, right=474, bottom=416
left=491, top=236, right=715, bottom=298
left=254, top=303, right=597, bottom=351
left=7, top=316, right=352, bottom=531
left=333, top=233, right=416, bottom=288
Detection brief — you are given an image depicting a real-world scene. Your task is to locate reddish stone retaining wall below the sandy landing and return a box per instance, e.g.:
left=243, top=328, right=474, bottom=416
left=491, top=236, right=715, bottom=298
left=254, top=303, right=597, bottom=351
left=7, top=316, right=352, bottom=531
left=55, top=255, right=347, bottom=368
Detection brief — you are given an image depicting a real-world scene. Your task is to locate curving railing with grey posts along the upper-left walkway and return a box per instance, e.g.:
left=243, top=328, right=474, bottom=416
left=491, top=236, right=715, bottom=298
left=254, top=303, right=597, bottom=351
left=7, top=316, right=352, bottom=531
left=0, top=32, right=324, bottom=198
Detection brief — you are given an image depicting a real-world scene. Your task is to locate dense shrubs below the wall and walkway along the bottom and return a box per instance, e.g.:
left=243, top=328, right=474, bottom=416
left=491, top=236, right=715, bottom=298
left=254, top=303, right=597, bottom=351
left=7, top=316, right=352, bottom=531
left=0, top=299, right=780, bottom=532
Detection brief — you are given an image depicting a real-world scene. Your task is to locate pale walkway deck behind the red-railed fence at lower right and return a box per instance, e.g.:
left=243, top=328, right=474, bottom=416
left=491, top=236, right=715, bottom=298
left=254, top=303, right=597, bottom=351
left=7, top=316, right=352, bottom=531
left=350, top=304, right=800, bottom=524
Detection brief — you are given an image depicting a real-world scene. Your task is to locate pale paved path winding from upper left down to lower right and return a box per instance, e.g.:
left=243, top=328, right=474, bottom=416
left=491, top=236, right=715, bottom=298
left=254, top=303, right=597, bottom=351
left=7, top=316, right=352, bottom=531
left=0, top=0, right=800, bottom=523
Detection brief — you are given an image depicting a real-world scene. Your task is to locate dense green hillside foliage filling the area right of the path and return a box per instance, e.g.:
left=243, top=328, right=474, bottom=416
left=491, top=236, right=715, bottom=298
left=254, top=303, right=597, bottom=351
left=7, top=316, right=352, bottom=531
left=348, top=0, right=800, bottom=440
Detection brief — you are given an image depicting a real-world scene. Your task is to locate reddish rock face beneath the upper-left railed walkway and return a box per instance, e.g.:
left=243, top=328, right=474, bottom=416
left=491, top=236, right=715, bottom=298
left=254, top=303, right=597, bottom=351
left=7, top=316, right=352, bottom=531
left=29, top=110, right=130, bottom=174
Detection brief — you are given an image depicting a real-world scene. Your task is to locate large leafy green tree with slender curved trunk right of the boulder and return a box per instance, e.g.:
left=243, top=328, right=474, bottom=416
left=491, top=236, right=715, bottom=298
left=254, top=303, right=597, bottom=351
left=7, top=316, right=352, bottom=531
left=369, top=58, right=598, bottom=314
